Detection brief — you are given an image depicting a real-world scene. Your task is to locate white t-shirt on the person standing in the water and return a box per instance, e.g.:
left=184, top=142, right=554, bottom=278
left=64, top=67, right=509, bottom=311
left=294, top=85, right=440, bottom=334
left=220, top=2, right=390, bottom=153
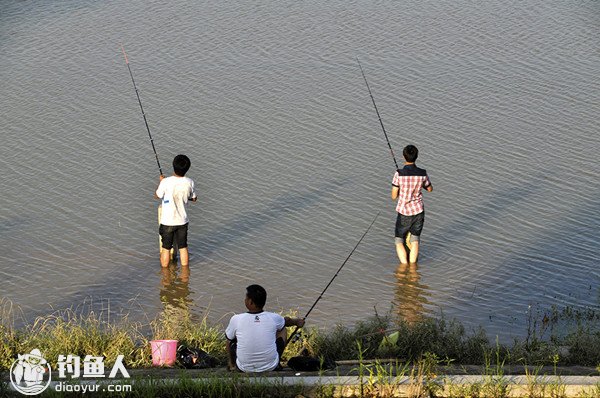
left=156, top=176, right=196, bottom=226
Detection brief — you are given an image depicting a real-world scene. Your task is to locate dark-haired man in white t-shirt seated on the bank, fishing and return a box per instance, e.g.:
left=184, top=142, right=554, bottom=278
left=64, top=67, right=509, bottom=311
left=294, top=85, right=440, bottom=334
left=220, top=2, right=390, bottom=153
left=225, top=285, right=304, bottom=372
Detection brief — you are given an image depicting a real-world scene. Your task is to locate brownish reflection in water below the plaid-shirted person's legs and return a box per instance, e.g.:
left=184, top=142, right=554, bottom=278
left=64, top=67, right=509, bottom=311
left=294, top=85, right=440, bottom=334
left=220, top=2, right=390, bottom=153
left=394, top=264, right=429, bottom=323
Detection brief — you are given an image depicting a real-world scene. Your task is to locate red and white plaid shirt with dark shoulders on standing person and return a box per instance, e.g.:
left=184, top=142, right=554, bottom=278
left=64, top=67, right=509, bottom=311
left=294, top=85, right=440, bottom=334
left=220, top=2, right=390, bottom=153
left=392, top=164, right=431, bottom=216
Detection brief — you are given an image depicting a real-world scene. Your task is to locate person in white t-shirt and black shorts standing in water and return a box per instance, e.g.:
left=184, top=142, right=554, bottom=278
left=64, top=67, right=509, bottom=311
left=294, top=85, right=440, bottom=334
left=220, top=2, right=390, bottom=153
left=154, top=155, right=196, bottom=267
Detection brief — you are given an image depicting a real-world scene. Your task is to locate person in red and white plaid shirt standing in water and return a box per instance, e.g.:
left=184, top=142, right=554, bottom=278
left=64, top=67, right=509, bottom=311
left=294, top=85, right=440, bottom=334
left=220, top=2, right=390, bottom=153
left=392, top=145, right=433, bottom=264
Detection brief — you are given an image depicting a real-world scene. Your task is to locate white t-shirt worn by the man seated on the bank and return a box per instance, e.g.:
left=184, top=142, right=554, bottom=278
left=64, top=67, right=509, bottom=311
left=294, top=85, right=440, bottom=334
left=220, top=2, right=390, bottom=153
left=225, top=311, right=285, bottom=372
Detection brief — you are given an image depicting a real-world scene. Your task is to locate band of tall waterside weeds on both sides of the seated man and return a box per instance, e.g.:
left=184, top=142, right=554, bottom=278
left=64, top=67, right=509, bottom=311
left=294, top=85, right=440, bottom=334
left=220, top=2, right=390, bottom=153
left=0, top=300, right=600, bottom=370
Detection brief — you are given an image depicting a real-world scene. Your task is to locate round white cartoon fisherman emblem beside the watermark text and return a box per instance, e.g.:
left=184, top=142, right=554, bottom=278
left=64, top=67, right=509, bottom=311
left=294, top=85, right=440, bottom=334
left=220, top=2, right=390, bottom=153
left=10, top=348, right=52, bottom=395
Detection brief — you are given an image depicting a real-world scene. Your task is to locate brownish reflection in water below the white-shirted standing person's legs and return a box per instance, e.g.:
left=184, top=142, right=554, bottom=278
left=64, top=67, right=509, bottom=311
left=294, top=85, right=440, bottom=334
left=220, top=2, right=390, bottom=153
left=160, top=263, right=193, bottom=312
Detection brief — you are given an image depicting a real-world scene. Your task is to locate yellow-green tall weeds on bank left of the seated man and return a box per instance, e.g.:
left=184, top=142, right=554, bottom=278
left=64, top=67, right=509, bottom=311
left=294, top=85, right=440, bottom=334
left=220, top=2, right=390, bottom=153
left=0, top=300, right=226, bottom=370
